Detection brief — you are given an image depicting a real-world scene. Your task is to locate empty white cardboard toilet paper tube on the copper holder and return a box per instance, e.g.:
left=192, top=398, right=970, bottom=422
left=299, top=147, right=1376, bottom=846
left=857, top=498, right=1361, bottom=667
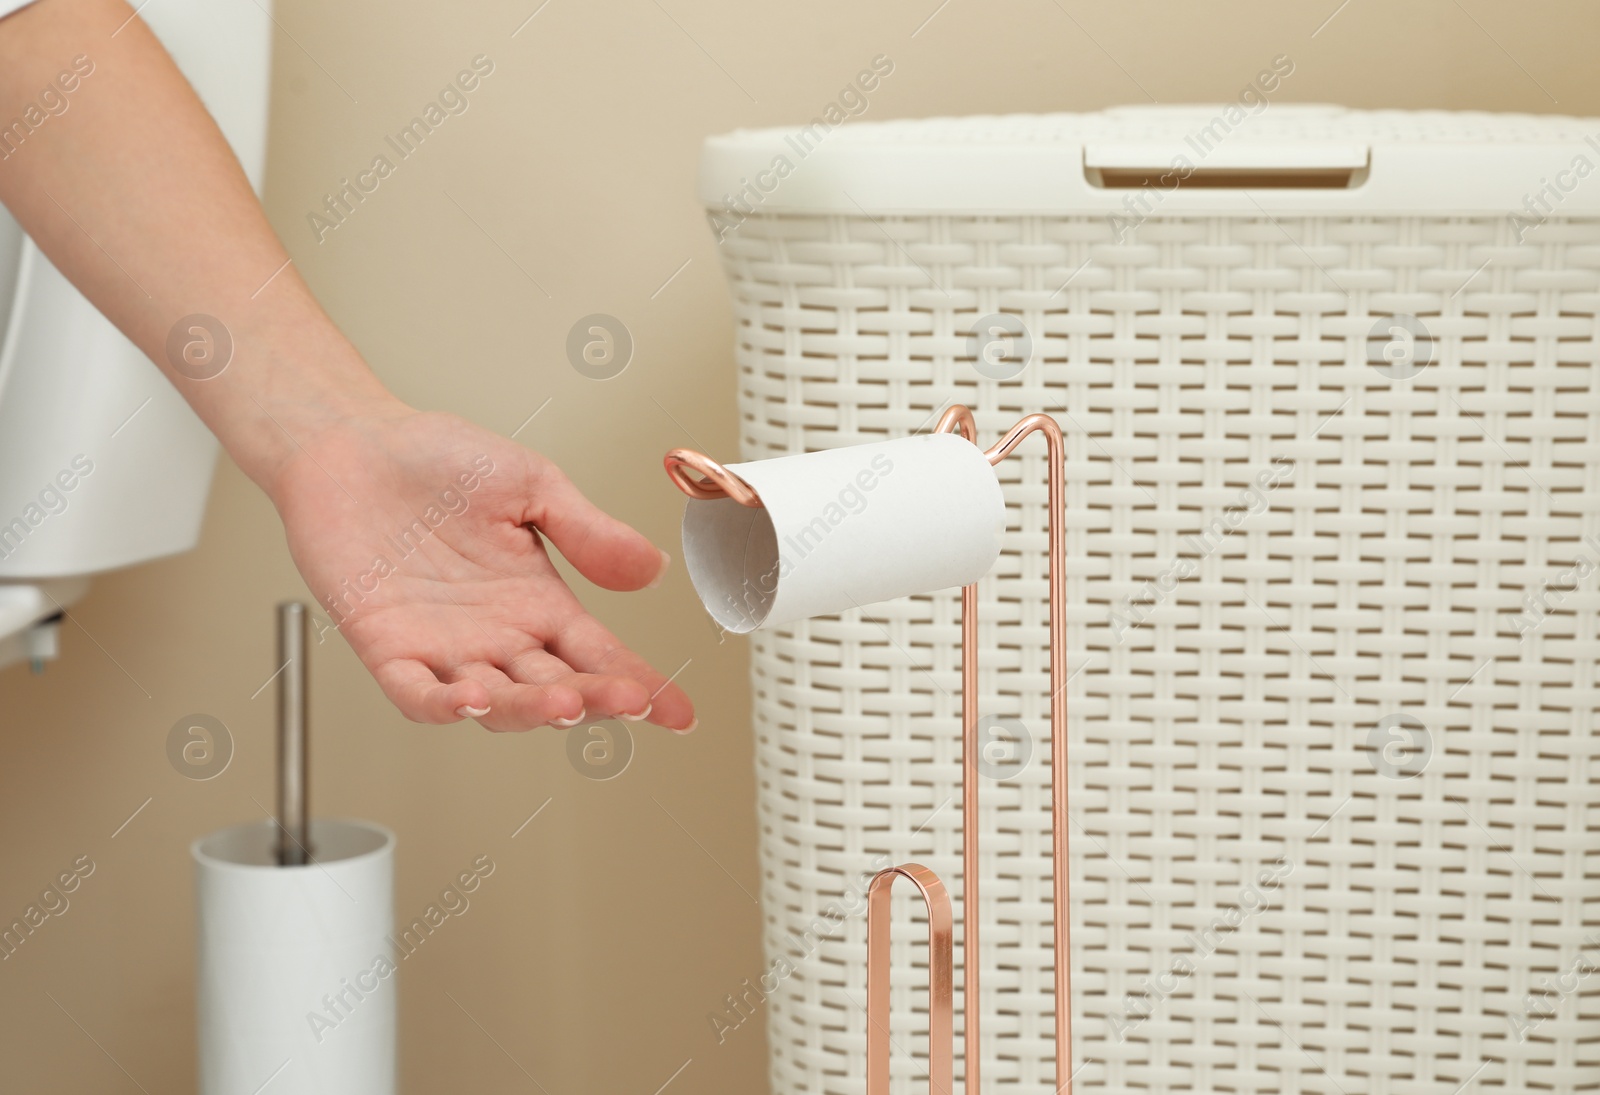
left=683, top=434, right=1005, bottom=634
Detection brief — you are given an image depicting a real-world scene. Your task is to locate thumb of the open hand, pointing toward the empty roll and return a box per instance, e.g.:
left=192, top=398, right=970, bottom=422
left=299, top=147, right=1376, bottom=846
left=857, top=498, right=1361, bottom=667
left=531, top=456, right=670, bottom=589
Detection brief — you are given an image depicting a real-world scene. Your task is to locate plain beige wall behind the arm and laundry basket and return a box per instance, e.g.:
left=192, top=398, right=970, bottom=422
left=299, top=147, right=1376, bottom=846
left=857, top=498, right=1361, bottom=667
left=9, top=0, right=1600, bottom=1095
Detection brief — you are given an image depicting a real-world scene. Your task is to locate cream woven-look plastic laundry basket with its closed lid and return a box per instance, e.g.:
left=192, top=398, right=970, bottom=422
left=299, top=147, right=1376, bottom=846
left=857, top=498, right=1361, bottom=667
left=701, top=108, right=1600, bottom=1095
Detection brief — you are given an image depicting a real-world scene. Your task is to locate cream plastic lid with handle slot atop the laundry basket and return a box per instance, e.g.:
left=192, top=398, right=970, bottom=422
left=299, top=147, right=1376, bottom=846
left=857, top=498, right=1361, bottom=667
left=699, top=104, right=1600, bottom=223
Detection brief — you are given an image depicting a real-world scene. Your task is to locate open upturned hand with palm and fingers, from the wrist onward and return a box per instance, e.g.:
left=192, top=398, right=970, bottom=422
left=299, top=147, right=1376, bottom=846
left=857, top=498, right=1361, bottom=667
left=269, top=402, right=694, bottom=732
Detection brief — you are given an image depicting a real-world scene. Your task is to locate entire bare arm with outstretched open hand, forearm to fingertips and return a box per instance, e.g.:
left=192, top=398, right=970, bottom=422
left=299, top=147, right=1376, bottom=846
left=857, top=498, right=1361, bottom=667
left=0, top=0, right=694, bottom=730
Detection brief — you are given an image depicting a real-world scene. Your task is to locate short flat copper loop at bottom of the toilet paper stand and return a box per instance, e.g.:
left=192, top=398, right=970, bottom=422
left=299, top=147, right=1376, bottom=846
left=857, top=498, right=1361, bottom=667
left=867, top=863, right=955, bottom=1095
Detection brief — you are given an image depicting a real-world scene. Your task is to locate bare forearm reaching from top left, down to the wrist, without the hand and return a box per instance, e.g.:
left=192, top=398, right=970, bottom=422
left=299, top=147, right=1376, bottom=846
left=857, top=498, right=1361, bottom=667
left=0, top=0, right=390, bottom=493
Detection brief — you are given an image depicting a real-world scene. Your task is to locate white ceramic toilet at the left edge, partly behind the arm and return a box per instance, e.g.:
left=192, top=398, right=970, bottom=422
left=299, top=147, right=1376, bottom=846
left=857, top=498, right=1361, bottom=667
left=0, top=0, right=274, bottom=664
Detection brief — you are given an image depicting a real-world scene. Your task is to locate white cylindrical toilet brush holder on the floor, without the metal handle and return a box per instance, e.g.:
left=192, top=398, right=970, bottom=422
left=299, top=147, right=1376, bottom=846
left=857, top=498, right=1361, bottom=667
left=192, top=821, right=398, bottom=1095
